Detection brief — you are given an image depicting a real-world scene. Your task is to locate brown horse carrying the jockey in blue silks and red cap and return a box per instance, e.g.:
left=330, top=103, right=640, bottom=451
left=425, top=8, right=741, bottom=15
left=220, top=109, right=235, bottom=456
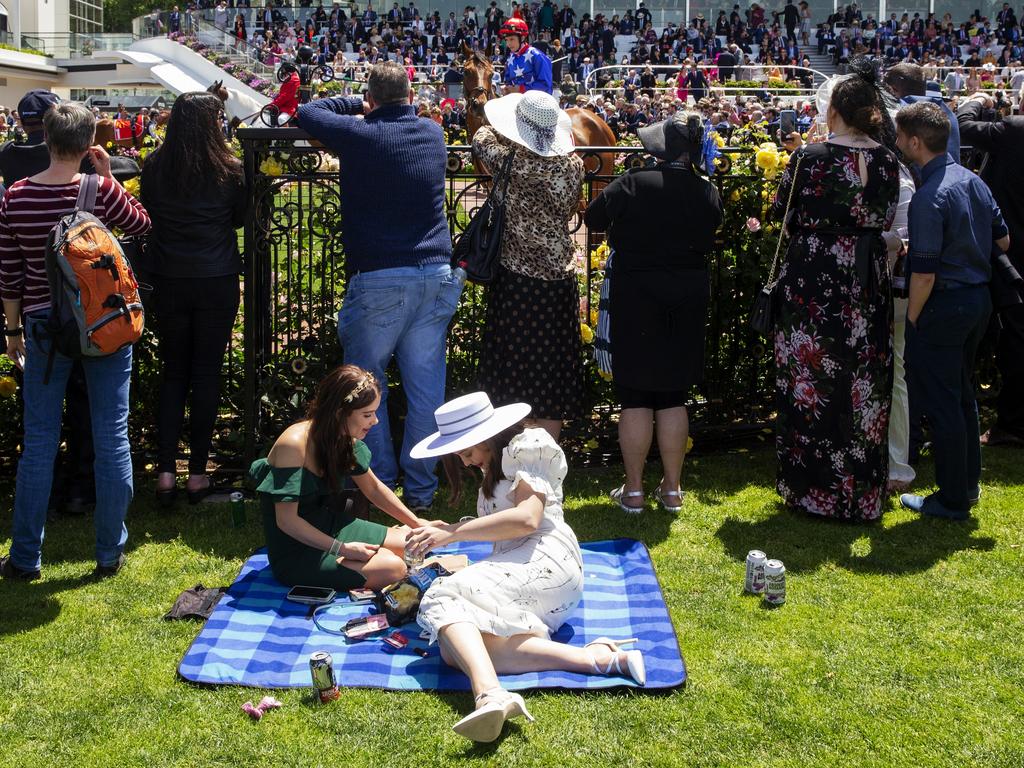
left=462, top=43, right=615, bottom=175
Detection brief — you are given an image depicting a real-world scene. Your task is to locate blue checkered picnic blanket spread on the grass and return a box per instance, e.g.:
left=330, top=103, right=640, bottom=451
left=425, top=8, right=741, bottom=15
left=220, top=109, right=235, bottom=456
left=178, top=539, right=686, bottom=690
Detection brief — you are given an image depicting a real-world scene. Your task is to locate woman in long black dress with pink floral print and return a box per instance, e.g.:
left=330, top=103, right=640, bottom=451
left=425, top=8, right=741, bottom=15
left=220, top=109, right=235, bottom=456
left=771, top=74, right=899, bottom=520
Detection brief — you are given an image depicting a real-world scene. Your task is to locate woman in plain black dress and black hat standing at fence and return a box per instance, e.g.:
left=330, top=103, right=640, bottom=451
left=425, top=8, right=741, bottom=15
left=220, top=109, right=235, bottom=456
left=586, top=113, right=722, bottom=513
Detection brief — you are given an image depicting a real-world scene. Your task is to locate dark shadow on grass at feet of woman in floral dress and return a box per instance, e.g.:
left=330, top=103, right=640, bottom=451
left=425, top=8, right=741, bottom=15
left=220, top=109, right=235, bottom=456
left=715, top=502, right=995, bottom=575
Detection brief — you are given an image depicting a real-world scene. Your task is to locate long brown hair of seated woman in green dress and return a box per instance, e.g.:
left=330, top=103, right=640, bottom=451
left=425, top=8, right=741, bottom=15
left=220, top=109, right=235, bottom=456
left=306, top=366, right=381, bottom=493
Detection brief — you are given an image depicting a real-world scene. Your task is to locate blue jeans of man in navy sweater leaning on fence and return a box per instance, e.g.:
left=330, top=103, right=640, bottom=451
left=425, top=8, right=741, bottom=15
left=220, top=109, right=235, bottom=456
left=338, top=264, right=464, bottom=506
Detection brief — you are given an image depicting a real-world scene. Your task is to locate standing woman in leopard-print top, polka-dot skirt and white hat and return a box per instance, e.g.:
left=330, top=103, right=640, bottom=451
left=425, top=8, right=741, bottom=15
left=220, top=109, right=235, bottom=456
left=473, top=91, right=584, bottom=440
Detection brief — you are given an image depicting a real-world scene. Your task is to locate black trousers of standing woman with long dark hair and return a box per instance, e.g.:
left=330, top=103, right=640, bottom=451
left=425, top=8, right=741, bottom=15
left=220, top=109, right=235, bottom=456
left=153, top=274, right=239, bottom=474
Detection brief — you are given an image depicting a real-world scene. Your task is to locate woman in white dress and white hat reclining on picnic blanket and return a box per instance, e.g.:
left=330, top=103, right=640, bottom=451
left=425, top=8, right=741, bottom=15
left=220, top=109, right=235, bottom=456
left=406, top=392, right=646, bottom=741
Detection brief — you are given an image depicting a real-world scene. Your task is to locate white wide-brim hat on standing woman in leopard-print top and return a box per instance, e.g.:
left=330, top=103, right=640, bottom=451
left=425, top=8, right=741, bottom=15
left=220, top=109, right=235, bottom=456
left=483, top=91, right=575, bottom=158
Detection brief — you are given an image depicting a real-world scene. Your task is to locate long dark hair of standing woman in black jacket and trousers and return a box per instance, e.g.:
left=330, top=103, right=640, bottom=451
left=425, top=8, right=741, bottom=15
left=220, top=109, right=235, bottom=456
left=145, top=91, right=242, bottom=197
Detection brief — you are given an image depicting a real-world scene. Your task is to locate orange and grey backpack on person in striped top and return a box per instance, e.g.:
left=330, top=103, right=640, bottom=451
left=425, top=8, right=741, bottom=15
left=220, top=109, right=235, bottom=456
left=43, top=174, right=145, bottom=383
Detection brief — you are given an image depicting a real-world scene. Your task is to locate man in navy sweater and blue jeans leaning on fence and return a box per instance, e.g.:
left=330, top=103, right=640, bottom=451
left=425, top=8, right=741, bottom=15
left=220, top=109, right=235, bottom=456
left=297, top=61, right=463, bottom=516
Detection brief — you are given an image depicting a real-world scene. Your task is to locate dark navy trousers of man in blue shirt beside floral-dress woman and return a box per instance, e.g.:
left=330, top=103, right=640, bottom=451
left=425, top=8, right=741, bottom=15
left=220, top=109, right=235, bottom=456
left=906, top=285, right=992, bottom=511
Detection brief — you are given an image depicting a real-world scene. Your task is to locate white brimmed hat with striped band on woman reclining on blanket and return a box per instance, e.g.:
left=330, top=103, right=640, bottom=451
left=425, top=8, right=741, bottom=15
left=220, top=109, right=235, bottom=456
left=409, top=393, right=530, bottom=459
